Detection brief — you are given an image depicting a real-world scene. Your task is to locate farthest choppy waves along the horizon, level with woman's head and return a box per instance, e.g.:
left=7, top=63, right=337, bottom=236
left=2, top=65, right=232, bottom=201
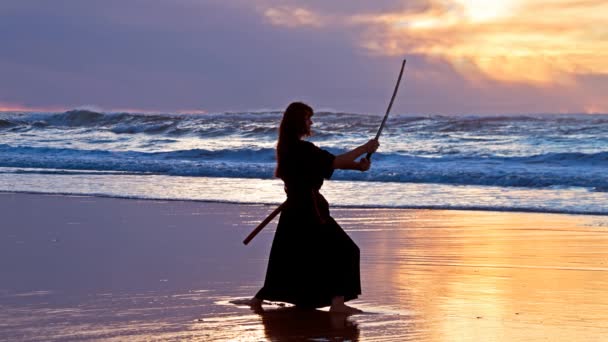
left=0, top=110, right=608, bottom=136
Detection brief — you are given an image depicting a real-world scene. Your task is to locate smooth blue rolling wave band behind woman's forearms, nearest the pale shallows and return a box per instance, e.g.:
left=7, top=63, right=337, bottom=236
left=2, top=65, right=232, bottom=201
left=0, top=144, right=608, bottom=191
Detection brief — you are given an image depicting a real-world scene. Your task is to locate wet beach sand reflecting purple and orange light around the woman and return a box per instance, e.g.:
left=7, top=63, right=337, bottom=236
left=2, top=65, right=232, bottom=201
left=0, top=193, right=608, bottom=341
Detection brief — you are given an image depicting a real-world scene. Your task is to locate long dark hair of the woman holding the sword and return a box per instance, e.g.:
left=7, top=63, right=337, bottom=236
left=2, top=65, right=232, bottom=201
left=274, top=102, right=314, bottom=178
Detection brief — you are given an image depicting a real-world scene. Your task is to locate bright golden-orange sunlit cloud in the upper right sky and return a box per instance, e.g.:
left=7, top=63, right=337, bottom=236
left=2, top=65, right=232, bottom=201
left=351, top=0, right=608, bottom=84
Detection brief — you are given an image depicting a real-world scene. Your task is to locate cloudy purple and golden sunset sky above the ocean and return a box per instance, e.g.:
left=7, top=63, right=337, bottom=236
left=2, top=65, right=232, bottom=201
left=0, top=0, right=608, bottom=115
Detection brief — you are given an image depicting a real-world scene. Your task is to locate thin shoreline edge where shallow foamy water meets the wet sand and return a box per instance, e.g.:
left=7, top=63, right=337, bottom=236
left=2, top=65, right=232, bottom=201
left=0, top=190, right=608, bottom=216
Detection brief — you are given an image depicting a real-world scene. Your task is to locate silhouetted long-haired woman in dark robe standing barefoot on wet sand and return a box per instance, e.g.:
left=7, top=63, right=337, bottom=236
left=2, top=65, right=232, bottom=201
left=251, top=102, right=379, bottom=313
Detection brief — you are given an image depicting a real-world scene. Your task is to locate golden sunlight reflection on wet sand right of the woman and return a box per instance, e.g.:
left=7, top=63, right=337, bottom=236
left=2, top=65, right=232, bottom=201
left=358, top=211, right=608, bottom=341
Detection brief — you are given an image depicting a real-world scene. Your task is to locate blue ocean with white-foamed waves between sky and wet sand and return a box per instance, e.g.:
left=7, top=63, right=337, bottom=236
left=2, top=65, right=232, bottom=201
left=0, top=109, right=608, bottom=215
